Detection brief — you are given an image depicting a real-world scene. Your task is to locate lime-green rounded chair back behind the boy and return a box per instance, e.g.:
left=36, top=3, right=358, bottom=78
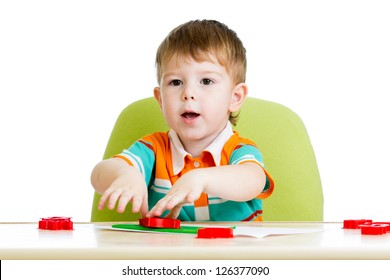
left=91, top=97, right=324, bottom=222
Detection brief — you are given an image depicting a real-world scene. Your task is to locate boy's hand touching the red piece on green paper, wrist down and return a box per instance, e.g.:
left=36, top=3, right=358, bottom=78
left=146, top=169, right=206, bottom=219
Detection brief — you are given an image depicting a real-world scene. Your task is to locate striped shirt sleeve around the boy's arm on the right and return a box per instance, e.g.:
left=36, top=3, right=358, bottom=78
left=229, top=144, right=274, bottom=199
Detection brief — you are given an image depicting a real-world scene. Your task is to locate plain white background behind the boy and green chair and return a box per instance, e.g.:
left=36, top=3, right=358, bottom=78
left=0, top=0, right=390, bottom=222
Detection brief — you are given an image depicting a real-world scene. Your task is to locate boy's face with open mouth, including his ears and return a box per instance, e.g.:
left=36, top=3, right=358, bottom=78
left=154, top=55, right=247, bottom=150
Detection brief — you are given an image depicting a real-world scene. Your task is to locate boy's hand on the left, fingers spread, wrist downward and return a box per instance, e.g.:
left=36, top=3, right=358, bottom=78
left=98, top=175, right=148, bottom=217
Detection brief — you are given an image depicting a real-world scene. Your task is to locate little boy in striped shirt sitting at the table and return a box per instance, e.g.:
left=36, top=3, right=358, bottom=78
left=91, top=20, right=273, bottom=221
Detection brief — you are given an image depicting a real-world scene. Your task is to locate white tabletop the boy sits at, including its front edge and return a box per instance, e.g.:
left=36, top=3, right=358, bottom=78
left=0, top=222, right=390, bottom=259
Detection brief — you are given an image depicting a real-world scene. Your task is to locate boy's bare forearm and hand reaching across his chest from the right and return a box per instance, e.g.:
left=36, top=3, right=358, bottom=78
left=147, top=162, right=266, bottom=218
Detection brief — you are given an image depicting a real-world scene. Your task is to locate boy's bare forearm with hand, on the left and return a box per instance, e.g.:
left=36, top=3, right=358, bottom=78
left=91, top=158, right=148, bottom=216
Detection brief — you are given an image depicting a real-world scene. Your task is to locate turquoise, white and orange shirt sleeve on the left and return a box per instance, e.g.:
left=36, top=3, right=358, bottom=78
left=114, top=139, right=156, bottom=186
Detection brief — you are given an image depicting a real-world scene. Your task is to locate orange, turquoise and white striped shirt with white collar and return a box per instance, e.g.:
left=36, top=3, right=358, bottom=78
left=114, top=123, right=274, bottom=221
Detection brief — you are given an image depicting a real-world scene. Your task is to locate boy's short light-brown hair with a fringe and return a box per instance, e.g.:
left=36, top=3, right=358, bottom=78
left=156, top=20, right=247, bottom=124
